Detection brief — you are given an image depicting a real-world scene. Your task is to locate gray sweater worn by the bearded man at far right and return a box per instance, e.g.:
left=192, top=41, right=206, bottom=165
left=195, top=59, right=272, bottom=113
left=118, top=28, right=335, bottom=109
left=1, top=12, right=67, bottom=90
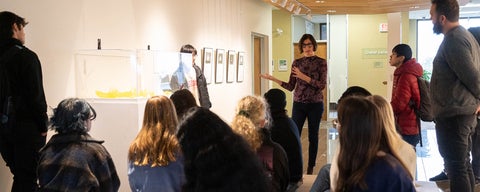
left=430, top=26, right=480, bottom=118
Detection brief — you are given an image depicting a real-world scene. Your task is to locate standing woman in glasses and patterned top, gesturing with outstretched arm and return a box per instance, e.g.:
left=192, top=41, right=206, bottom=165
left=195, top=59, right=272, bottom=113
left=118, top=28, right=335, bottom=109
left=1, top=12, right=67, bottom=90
left=260, top=34, right=327, bottom=174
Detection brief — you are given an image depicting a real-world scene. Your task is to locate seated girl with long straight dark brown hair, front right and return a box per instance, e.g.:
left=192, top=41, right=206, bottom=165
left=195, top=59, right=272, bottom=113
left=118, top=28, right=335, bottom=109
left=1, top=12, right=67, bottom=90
left=332, top=96, right=416, bottom=192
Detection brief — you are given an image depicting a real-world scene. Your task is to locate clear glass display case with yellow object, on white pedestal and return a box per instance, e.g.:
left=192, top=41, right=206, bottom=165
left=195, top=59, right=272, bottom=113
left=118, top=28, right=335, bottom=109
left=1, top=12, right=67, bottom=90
left=75, top=50, right=196, bottom=99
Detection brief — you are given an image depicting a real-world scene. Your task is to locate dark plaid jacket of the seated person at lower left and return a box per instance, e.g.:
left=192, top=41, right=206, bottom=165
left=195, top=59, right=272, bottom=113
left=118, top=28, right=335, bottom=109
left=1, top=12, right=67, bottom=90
left=37, top=133, right=120, bottom=192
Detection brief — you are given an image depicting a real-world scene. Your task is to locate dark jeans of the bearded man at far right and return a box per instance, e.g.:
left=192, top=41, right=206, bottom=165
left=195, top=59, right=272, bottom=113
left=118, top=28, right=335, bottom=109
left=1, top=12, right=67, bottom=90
left=435, top=114, right=477, bottom=192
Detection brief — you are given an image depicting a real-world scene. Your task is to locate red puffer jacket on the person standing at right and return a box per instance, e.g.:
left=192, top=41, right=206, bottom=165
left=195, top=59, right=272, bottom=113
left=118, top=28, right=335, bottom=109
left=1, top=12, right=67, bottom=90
left=390, top=58, right=423, bottom=135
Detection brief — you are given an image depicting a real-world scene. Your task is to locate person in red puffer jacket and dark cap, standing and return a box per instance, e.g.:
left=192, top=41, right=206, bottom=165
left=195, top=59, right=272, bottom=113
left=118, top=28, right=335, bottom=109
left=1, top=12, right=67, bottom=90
left=389, top=44, right=423, bottom=148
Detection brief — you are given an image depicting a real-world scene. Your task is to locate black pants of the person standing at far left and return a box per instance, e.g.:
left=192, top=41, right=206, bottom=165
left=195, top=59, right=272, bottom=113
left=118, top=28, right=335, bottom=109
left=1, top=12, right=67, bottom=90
left=0, top=122, right=46, bottom=192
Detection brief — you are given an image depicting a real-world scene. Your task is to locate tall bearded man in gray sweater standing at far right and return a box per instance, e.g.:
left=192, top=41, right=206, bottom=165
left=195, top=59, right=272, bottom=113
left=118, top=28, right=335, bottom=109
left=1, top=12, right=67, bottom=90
left=430, top=0, right=480, bottom=192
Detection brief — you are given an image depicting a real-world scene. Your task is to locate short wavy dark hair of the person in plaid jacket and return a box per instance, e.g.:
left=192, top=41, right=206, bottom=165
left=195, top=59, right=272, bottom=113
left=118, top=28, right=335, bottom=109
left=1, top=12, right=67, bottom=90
left=50, top=98, right=97, bottom=133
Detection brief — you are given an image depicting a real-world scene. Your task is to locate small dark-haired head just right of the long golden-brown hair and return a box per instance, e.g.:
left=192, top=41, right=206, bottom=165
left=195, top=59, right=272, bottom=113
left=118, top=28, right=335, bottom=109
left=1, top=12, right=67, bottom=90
left=170, top=89, right=197, bottom=120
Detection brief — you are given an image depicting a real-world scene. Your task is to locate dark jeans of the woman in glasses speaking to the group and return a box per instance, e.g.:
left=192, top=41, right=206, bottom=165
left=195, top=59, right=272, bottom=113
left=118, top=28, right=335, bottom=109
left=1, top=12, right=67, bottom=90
left=292, top=102, right=323, bottom=167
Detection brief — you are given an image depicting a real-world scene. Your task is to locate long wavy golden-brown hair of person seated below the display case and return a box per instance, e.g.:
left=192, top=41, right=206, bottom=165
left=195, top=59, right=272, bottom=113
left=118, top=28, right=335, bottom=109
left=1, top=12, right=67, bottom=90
left=128, top=96, right=180, bottom=167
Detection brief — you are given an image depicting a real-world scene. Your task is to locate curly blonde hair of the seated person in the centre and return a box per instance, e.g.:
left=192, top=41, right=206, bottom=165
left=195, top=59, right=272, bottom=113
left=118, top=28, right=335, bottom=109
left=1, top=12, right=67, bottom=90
left=232, top=96, right=269, bottom=151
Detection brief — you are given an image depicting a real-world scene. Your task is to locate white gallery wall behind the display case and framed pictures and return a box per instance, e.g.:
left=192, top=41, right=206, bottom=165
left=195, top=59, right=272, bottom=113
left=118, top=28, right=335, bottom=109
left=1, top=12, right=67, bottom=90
left=0, top=0, right=272, bottom=191
